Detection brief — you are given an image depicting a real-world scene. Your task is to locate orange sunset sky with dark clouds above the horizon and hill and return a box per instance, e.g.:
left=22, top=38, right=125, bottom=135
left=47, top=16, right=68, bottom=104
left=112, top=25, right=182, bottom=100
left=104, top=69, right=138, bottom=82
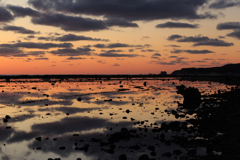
left=0, top=0, right=240, bottom=75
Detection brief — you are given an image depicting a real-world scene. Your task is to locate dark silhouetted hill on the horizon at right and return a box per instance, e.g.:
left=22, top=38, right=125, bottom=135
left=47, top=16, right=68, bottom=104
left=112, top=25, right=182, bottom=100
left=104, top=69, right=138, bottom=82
left=172, top=63, right=240, bottom=76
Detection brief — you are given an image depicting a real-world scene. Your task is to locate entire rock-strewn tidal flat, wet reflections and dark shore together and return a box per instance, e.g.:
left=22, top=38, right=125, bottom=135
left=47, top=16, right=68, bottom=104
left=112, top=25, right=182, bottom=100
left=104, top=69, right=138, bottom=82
left=0, top=77, right=240, bottom=160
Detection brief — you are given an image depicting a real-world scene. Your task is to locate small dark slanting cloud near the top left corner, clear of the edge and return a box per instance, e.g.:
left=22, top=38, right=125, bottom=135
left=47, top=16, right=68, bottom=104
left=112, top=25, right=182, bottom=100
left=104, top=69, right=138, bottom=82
left=7, top=5, right=40, bottom=17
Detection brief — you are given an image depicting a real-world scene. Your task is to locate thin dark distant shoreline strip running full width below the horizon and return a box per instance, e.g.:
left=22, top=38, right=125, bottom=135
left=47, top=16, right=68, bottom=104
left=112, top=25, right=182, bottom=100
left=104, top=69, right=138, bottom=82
left=0, top=74, right=240, bottom=85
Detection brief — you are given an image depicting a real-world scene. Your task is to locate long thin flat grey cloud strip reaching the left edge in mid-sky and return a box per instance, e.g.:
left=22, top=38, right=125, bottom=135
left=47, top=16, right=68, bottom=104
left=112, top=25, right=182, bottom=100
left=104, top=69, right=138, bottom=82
left=0, top=42, right=73, bottom=49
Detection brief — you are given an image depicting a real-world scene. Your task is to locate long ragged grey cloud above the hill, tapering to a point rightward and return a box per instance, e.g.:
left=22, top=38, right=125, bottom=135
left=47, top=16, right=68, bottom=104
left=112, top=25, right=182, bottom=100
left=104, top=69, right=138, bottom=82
left=168, top=35, right=234, bottom=47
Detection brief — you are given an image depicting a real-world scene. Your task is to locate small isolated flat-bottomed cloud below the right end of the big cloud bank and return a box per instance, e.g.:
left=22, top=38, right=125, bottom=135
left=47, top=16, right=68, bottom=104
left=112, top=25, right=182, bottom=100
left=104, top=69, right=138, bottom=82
left=156, top=22, right=199, bottom=28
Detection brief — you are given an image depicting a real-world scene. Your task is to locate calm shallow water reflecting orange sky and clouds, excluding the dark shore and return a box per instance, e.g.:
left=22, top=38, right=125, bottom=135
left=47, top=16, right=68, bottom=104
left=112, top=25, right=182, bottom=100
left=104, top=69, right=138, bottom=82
left=0, top=79, right=231, bottom=160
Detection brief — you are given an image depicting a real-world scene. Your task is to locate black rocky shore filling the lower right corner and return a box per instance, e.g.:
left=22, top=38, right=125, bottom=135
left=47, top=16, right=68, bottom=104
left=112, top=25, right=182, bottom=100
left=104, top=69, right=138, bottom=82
left=168, top=87, right=240, bottom=160
